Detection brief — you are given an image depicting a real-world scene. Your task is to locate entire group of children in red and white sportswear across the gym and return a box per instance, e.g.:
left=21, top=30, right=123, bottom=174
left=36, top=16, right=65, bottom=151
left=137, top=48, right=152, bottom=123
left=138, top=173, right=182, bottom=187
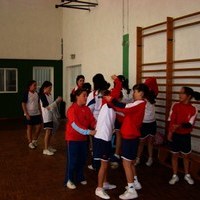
left=22, top=74, right=200, bottom=199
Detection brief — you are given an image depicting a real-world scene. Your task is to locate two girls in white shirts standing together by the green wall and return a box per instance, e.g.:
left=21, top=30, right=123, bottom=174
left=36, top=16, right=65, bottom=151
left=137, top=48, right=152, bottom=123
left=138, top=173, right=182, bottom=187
left=22, top=80, right=62, bottom=156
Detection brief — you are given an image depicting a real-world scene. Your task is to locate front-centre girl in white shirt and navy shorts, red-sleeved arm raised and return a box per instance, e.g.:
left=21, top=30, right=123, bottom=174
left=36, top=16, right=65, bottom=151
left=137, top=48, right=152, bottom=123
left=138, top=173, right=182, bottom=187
left=93, top=75, right=121, bottom=199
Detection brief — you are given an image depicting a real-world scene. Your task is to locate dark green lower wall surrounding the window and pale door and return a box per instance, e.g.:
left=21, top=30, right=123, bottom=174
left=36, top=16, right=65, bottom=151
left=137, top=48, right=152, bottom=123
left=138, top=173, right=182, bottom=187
left=0, top=59, right=63, bottom=118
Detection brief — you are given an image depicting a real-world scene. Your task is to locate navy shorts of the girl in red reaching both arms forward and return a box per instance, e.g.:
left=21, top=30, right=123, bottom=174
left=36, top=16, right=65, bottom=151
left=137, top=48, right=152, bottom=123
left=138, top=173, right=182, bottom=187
left=121, top=138, right=139, bottom=161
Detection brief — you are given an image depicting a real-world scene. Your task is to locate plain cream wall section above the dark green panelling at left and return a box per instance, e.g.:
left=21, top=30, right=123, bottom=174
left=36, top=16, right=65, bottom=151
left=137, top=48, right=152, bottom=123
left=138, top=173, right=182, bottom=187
left=0, top=0, right=62, bottom=60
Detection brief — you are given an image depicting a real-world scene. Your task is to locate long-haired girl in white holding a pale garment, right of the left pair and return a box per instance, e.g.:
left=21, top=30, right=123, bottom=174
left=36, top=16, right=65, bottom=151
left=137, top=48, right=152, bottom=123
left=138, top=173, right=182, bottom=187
left=39, top=81, right=62, bottom=156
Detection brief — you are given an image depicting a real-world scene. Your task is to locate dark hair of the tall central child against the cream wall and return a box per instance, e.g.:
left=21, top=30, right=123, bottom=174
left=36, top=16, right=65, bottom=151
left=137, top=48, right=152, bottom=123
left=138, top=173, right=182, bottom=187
left=92, top=73, right=110, bottom=92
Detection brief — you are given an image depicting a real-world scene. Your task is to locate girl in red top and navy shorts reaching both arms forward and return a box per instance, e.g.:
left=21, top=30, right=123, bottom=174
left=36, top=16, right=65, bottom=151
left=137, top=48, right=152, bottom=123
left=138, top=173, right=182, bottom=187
left=109, top=84, right=148, bottom=199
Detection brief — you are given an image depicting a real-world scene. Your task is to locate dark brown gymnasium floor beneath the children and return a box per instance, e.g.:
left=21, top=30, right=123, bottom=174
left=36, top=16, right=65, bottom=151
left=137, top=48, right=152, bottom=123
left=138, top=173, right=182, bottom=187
left=0, top=120, right=200, bottom=200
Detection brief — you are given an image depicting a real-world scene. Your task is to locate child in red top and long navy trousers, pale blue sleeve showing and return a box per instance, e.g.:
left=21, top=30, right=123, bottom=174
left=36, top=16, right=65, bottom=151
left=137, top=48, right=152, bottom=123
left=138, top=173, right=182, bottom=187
left=64, top=89, right=96, bottom=189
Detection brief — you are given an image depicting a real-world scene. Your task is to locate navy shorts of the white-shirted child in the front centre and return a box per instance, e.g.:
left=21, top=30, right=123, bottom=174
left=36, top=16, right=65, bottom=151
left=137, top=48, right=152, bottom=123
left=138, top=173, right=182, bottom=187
left=93, top=138, right=112, bottom=161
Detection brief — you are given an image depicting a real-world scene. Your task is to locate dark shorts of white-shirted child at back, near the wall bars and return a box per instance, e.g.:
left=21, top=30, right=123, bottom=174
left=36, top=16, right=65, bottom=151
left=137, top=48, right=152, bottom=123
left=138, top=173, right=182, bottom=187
left=140, top=121, right=157, bottom=139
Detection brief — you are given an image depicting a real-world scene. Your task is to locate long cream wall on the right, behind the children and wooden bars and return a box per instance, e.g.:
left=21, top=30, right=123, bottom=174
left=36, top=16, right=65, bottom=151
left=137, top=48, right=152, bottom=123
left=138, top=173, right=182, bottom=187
left=63, top=0, right=200, bottom=85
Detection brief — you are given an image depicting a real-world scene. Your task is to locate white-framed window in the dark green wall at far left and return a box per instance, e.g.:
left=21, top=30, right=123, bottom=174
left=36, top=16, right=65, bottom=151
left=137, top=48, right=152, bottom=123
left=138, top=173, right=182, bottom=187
left=0, top=68, right=18, bottom=93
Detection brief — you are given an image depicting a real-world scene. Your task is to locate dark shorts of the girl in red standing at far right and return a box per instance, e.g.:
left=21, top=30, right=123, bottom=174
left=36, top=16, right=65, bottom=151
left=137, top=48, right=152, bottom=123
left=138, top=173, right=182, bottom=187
left=170, top=133, right=192, bottom=154
